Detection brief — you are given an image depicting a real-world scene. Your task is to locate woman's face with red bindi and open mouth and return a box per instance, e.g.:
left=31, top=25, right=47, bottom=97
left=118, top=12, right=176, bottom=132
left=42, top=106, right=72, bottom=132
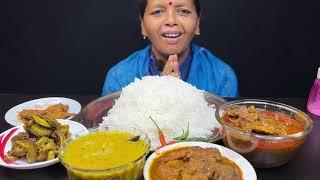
left=141, top=0, right=199, bottom=57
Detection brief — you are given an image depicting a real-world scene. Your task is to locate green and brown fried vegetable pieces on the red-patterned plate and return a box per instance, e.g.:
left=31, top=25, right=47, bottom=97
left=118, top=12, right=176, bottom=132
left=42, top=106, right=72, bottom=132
left=6, top=116, right=71, bottom=163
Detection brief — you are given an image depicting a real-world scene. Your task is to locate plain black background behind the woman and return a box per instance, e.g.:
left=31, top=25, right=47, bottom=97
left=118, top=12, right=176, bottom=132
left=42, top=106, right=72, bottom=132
left=0, top=0, right=320, bottom=97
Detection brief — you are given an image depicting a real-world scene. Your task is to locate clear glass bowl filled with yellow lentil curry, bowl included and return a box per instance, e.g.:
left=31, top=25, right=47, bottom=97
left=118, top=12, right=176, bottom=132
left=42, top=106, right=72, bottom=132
left=58, top=125, right=150, bottom=180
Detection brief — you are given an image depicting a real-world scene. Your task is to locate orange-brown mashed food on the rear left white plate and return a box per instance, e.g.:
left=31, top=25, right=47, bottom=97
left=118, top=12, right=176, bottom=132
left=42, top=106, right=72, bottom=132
left=19, top=103, right=75, bottom=121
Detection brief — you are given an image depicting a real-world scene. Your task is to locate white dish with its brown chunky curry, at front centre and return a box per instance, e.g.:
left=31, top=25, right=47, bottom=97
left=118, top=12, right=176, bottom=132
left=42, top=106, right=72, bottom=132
left=143, top=142, right=257, bottom=180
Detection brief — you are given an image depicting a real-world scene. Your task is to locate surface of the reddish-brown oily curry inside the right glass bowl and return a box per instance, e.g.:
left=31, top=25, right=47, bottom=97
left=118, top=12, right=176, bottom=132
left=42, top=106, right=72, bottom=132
left=222, top=105, right=303, bottom=135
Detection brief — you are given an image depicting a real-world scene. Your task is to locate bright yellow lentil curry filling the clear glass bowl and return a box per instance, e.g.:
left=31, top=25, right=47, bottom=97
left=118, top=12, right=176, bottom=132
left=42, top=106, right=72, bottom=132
left=63, top=131, right=146, bottom=170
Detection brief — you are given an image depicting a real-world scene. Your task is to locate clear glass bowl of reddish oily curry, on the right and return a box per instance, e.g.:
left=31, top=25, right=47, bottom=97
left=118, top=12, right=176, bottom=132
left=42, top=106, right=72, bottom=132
left=216, top=99, right=313, bottom=168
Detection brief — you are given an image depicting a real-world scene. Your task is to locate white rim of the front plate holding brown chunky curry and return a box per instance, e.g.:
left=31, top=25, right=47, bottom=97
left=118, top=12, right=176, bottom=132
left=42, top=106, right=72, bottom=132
left=143, top=142, right=257, bottom=180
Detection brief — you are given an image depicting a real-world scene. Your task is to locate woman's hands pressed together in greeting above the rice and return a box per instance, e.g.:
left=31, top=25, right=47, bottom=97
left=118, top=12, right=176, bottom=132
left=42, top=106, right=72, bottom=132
left=161, top=54, right=180, bottom=78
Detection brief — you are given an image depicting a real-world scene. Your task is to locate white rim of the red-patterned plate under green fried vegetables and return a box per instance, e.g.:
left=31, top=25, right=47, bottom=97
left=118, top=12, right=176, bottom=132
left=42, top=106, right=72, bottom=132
left=0, top=119, right=87, bottom=169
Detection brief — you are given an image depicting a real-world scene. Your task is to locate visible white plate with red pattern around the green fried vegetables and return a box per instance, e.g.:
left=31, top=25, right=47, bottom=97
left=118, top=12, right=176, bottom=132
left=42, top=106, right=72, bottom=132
left=0, top=120, right=87, bottom=169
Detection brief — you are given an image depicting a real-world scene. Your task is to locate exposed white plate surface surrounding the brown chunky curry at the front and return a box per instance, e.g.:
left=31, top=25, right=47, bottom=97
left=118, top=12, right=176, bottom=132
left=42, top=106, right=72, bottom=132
left=143, top=142, right=257, bottom=180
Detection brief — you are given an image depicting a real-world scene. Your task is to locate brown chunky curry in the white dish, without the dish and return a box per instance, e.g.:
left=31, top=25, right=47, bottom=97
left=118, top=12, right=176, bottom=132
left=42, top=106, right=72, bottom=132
left=149, top=147, right=243, bottom=180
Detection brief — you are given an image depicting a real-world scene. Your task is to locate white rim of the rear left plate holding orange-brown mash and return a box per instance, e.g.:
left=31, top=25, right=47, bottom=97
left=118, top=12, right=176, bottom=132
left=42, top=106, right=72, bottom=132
left=4, top=96, right=82, bottom=127
